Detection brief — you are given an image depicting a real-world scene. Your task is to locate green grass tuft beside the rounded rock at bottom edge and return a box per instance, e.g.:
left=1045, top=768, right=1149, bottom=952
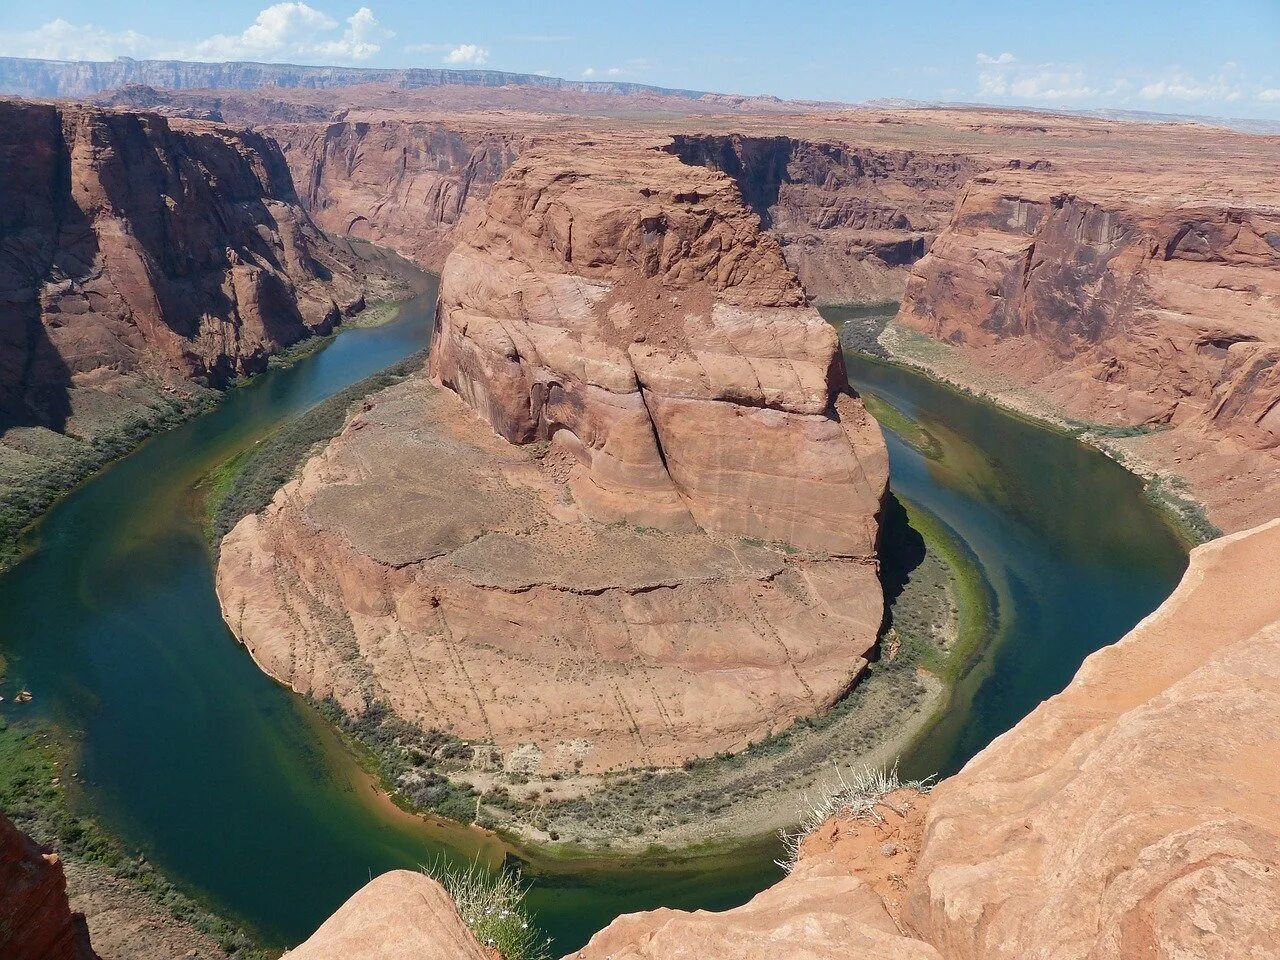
left=422, top=863, right=550, bottom=960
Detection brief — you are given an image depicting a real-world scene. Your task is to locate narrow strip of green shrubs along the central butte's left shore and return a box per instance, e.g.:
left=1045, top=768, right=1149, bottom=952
left=204, top=353, right=426, bottom=544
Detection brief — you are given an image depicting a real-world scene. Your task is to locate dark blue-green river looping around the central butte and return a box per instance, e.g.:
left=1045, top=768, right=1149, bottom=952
left=0, top=289, right=1187, bottom=952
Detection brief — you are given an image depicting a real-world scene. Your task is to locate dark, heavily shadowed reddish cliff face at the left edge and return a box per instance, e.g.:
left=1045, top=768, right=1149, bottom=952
left=0, top=101, right=373, bottom=429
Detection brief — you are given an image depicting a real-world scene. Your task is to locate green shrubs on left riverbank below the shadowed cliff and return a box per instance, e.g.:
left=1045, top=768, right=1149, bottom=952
left=0, top=388, right=216, bottom=572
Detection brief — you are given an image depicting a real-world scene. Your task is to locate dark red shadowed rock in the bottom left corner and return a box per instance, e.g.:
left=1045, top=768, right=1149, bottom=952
left=0, top=814, right=97, bottom=960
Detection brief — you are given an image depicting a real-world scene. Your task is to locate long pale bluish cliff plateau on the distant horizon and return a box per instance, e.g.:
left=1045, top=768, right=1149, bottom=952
left=0, top=56, right=701, bottom=97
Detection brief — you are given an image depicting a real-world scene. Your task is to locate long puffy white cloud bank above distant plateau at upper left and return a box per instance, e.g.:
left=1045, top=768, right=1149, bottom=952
left=0, top=1, right=394, bottom=61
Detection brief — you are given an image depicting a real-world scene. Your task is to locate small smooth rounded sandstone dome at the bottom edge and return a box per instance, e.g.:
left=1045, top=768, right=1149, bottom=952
left=285, top=870, right=493, bottom=960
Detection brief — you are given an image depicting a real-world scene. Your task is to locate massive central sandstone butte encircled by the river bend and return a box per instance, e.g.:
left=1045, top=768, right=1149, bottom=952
left=218, top=140, right=887, bottom=783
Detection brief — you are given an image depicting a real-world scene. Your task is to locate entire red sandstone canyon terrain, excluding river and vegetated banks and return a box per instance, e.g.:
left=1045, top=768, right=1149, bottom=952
left=0, top=56, right=1280, bottom=960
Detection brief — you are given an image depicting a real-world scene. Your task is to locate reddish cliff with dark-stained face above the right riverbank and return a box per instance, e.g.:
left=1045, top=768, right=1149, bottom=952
left=899, top=170, right=1280, bottom=529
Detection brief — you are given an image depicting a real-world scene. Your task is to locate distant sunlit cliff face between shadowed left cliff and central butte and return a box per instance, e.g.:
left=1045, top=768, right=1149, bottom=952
left=264, top=120, right=524, bottom=270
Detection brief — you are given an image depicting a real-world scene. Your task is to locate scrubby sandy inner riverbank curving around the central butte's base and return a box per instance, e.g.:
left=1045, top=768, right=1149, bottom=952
left=204, top=350, right=991, bottom=860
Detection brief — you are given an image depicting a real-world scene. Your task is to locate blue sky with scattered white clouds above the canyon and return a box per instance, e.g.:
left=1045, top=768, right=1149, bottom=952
left=0, top=0, right=1280, bottom=119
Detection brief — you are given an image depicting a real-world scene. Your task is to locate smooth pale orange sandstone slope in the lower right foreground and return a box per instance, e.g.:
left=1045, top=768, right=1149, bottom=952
left=288, top=521, right=1280, bottom=960
